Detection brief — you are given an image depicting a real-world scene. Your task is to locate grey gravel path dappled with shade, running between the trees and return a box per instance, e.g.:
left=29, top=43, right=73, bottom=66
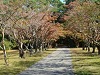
left=19, top=48, right=74, bottom=75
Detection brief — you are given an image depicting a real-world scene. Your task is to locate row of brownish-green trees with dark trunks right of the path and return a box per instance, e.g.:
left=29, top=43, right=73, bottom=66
left=65, top=0, right=100, bottom=54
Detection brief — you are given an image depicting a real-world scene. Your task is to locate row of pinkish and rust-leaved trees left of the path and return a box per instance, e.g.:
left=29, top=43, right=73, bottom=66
left=0, top=0, right=64, bottom=64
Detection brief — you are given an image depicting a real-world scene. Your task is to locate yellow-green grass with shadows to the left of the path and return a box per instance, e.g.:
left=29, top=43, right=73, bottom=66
left=0, top=49, right=56, bottom=75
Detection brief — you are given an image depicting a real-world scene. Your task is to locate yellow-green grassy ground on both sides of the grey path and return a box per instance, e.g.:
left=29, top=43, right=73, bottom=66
left=0, top=48, right=100, bottom=75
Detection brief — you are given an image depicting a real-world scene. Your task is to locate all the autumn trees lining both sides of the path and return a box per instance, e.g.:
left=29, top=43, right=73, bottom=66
left=0, top=0, right=100, bottom=64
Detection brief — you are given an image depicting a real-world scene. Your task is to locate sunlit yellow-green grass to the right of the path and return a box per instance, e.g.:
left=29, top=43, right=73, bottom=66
left=71, top=48, right=100, bottom=75
